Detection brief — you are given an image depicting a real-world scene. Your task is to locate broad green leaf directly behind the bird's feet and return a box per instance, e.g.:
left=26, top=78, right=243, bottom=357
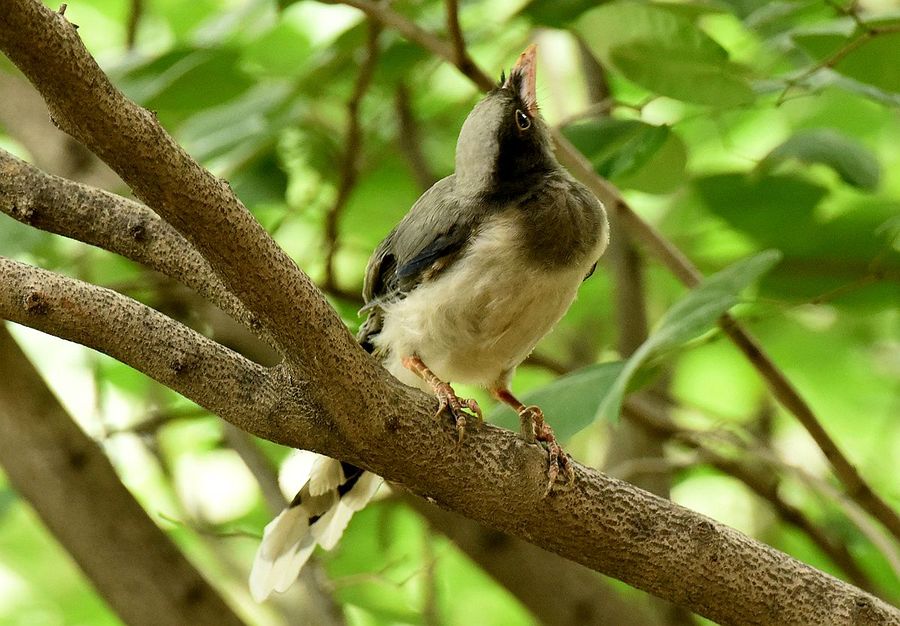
left=489, top=361, right=624, bottom=440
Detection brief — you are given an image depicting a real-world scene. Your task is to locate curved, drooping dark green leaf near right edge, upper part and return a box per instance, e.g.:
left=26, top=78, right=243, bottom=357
left=758, top=129, right=881, bottom=191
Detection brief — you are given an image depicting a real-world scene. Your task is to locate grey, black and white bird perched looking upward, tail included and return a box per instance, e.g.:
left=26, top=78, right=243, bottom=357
left=250, top=45, right=609, bottom=601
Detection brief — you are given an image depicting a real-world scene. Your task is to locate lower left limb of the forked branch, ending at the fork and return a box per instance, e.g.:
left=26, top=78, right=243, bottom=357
left=0, top=257, right=346, bottom=447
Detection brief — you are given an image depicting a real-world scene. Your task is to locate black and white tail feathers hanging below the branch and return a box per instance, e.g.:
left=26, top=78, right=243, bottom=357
left=250, top=452, right=382, bottom=602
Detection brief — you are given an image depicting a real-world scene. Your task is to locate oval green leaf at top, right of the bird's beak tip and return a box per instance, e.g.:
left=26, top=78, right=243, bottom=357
left=611, top=42, right=754, bottom=107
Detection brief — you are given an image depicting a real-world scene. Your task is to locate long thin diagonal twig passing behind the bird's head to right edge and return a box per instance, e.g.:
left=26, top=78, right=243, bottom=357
left=328, top=0, right=900, bottom=539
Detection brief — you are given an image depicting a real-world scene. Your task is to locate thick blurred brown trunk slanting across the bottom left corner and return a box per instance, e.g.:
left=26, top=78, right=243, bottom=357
left=0, top=324, right=243, bottom=626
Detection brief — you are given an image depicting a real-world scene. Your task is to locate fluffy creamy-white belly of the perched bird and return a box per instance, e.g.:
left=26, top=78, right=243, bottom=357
left=375, top=218, right=600, bottom=389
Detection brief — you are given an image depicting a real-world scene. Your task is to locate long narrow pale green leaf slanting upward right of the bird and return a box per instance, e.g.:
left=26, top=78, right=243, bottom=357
left=597, top=250, right=781, bottom=420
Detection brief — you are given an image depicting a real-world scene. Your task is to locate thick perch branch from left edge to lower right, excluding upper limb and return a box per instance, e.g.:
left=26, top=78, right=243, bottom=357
left=0, top=260, right=900, bottom=624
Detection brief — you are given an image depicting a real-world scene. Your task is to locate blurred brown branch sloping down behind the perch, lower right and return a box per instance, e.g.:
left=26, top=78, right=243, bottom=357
left=624, top=396, right=883, bottom=595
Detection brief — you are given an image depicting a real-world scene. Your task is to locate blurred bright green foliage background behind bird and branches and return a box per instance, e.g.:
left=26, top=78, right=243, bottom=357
left=0, top=0, right=900, bottom=626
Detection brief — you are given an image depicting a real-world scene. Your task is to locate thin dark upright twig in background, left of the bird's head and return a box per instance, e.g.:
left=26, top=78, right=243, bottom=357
left=323, top=22, right=381, bottom=291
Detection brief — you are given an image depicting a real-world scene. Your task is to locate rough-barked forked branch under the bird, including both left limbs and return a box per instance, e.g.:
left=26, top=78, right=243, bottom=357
left=0, top=0, right=900, bottom=624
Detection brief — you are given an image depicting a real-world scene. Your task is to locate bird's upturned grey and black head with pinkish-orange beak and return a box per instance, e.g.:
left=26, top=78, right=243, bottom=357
left=456, top=45, right=558, bottom=196
